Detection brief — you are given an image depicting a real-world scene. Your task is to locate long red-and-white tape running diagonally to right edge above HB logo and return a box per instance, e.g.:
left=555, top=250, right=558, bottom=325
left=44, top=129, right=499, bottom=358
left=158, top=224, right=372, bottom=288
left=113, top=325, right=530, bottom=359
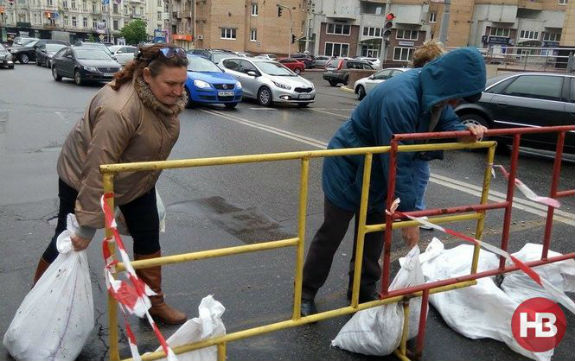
left=386, top=198, right=575, bottom=314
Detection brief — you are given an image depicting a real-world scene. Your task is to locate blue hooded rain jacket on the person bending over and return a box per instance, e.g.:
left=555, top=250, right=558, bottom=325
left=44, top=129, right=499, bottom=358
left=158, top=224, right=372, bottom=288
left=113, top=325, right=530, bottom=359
left=322, top=48, right=485, bottom=212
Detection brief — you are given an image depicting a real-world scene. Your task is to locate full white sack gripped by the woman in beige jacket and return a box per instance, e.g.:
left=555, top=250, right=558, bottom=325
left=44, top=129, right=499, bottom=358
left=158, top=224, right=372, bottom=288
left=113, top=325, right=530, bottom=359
left=3, top=214, right=94, bottom=361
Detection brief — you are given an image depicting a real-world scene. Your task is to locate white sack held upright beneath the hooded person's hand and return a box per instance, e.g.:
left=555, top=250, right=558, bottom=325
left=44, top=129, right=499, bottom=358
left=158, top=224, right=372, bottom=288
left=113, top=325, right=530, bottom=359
left=331, top=246, right=424, bottom=356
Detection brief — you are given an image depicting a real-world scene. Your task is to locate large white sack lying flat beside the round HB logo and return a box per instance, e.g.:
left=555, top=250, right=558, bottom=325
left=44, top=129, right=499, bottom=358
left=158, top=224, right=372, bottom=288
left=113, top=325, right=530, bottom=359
left=421, top=238, right=553, bottom=361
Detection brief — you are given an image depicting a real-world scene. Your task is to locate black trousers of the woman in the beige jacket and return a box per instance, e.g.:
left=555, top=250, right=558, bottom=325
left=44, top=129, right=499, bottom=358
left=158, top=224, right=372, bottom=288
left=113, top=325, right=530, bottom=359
left=42, top=179, right=160, bottom=263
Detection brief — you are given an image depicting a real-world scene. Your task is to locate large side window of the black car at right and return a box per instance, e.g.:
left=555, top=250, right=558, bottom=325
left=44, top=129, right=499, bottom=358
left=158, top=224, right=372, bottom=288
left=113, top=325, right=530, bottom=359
left=503, top=75, right=563, bottom=101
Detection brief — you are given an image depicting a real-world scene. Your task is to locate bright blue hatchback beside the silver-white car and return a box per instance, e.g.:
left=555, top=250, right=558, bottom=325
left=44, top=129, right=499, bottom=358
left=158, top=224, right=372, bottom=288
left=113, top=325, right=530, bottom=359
left=182, top=55, right=243, bottom=108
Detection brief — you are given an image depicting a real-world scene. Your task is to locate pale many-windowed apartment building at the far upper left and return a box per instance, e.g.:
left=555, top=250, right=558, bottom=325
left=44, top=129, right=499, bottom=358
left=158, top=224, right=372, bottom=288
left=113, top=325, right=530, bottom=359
left=0, top=0, right=165, bottom=42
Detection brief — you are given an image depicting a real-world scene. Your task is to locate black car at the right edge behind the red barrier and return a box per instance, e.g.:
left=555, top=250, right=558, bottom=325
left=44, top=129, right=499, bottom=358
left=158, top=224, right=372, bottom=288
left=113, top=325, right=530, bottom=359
left=455, top=73, right=575, bottom=154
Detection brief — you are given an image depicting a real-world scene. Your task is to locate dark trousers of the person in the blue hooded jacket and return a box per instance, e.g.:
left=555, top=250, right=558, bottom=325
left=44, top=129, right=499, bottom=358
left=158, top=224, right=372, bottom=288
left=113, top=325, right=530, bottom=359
left=302, top=199, right=384, bottom=300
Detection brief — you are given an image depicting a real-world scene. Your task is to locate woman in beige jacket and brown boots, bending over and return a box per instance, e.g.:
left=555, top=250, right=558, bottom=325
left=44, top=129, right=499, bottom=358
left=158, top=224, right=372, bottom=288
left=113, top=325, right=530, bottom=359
left=34, top=44, right=188, bottom=324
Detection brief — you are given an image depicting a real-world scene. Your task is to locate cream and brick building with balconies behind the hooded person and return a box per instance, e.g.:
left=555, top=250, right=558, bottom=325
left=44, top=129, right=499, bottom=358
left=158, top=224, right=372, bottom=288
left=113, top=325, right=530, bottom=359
left=308, top=0, right=575, bottom=62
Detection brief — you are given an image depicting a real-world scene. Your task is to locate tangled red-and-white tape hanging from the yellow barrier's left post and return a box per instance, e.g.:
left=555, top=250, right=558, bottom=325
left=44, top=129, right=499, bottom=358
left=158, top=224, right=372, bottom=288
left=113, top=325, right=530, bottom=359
left=100, top=193, right=178, bottom=361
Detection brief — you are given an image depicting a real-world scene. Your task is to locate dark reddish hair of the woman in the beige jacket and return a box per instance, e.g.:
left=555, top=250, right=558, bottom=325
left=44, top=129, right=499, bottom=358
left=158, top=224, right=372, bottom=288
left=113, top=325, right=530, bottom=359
left=112, top=43, right=188, bottom=90
